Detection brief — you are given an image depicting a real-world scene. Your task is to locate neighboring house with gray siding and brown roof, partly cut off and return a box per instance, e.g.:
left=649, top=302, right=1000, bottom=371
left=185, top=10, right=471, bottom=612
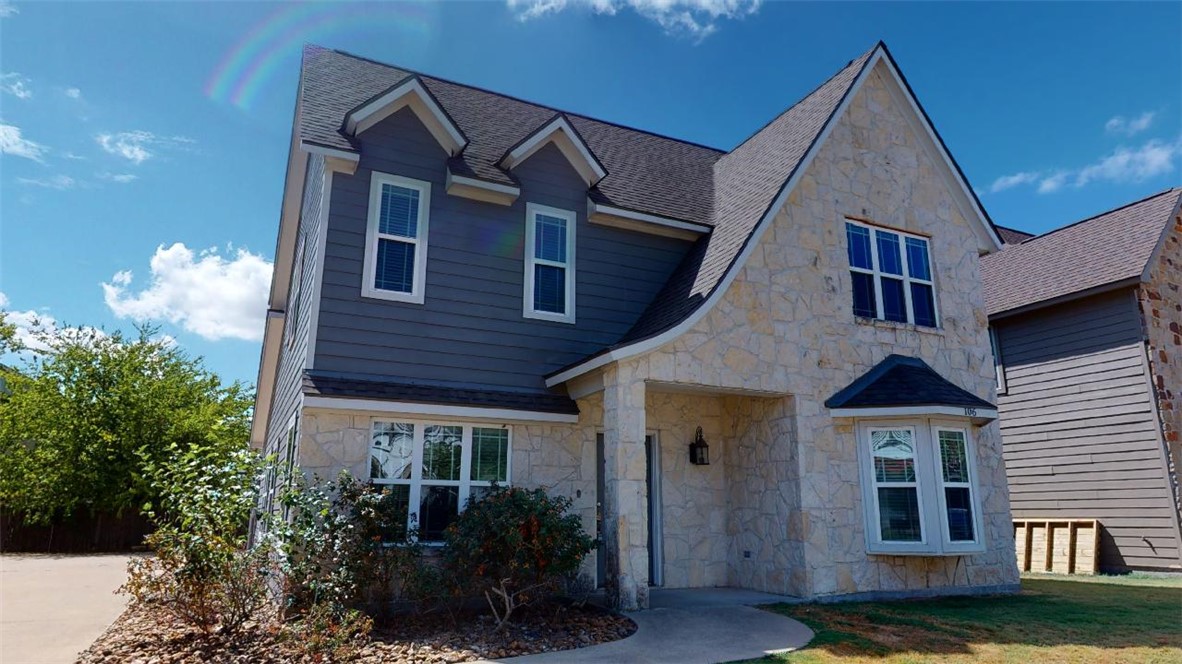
left=982, top=189, right=1182, bottom=569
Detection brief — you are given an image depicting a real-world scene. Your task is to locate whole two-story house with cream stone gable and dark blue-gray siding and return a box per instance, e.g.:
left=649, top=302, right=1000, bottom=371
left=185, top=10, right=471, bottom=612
left=252, top=45, right=1018, bottom=608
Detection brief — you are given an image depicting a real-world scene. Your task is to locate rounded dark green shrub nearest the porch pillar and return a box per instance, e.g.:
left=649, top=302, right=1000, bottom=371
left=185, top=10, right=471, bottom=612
left=443, top=487, right=595, bottom=629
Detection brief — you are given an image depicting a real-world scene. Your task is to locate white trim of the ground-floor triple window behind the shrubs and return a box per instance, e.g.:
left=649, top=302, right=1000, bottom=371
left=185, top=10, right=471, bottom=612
left=365, top=417, right=513, bottom=546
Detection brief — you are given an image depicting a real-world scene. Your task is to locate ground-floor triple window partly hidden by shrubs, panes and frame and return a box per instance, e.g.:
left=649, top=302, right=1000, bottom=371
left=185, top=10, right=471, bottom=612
left=370, top=421, right=509, bottom=542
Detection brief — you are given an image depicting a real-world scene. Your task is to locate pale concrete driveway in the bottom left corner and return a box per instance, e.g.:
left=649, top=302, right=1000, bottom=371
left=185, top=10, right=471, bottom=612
left=0, top=554, right=128, bottom=664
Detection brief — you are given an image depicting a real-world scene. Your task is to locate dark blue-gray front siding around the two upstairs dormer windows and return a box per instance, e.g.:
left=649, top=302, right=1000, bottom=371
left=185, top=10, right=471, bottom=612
left=314, top=105, right=689, bottom=391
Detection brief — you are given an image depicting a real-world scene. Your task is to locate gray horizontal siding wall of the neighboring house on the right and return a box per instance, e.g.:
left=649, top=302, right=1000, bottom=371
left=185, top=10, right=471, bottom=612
left=993, top=291, right=1180, bottom=568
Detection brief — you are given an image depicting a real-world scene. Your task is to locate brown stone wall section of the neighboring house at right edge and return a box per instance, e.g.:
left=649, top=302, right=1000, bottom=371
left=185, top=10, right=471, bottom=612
left=1137, top=216, right=1182, bottom=522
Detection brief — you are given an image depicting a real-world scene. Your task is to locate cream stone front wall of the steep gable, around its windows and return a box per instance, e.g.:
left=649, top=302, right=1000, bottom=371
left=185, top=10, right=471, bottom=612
left=621, top=65, right=1018, bottom=597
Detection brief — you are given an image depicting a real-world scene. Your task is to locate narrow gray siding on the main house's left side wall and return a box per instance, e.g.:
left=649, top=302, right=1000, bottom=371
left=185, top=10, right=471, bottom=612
left=265, top=155, right=324, bottom=460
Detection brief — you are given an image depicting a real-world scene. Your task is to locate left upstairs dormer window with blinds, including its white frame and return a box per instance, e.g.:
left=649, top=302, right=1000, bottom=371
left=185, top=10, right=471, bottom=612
left=362, top=171, right=431, bottom=304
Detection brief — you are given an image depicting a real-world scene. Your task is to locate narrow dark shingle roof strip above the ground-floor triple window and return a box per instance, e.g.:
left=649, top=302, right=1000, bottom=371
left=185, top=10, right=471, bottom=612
left=304, top=373, right=579, bottom=415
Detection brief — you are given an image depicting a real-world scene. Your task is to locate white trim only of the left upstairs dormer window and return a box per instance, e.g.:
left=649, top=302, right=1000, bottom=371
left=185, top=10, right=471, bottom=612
left=362, top=171, right=431, bottom=305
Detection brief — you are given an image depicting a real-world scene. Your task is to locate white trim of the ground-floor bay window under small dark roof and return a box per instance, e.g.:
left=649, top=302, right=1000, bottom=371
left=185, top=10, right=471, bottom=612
left=855, top=418, right=985, bottom=556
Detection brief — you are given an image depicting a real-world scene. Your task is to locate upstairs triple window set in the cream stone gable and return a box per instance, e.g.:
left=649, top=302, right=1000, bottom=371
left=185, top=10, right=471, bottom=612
left=845, top=221, right=936, bottom=327
